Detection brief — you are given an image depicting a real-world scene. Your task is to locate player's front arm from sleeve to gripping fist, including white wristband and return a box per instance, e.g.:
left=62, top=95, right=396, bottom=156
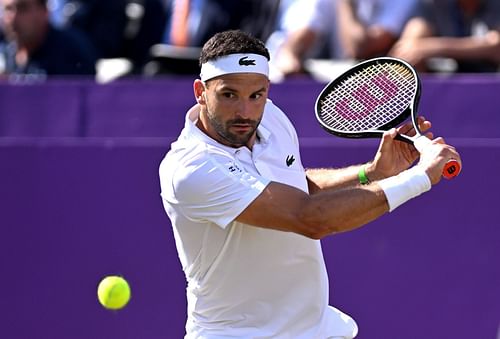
left=236, top=131, right=460, bottom=239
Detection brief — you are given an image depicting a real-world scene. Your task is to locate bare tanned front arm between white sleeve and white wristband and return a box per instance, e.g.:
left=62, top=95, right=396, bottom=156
left=236, top=178, right=389, bottom=239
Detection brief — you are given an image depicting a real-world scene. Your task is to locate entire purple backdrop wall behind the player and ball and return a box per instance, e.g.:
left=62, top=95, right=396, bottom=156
left=0, top=77, right=500, bottom=339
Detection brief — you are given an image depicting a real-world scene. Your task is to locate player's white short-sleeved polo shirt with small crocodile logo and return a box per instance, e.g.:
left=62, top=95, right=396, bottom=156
left=160, top=101, right=357, bottom=339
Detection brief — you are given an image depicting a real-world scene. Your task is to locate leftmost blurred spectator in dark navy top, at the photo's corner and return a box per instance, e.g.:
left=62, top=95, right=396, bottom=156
left=0, top=0, right=96, bottom=77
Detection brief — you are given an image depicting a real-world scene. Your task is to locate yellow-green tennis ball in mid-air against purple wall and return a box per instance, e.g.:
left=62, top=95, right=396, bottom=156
left=97, top=275, right=130, bottom=310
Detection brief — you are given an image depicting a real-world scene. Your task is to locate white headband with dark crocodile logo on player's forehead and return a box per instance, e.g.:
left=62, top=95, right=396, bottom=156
left=200, top=54, right=269, bottom=81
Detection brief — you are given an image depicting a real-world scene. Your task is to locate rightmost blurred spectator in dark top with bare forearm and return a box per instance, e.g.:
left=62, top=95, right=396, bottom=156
left=390, top=0, right=500, bottom=72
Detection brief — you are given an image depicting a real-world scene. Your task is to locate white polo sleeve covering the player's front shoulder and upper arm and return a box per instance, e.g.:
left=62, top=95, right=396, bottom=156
left=170, top=150, right=270, bottom=228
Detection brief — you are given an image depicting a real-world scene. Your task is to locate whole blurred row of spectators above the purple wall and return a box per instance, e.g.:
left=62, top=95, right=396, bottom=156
left=0, top=0, right=500, bottom=81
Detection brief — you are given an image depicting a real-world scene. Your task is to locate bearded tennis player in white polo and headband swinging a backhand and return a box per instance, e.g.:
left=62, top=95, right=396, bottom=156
left=160, top=31, right=460, bottom=339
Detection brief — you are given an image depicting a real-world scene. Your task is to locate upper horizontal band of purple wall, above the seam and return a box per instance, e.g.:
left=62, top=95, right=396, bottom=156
left=0, top=75, right=500, bottom=138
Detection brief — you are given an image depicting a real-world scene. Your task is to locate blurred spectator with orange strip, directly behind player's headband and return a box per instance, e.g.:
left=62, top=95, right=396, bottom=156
left=146, top=0, right=280, bottom=75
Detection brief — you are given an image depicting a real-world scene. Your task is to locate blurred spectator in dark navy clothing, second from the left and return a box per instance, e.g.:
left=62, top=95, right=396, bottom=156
left=59, top=0, right=167, bottom=73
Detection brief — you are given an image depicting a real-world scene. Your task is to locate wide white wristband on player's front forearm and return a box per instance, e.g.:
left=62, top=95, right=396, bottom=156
left=378, top=166, right=432, bottom=212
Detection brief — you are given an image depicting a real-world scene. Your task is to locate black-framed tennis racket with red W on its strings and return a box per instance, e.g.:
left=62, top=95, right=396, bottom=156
left=315, top=57, right=460, bottom=179
